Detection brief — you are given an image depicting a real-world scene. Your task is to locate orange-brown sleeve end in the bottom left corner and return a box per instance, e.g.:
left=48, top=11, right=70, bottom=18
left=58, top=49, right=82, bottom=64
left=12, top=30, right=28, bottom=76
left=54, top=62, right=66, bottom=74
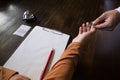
left=0, top=66, right=18, bottom=80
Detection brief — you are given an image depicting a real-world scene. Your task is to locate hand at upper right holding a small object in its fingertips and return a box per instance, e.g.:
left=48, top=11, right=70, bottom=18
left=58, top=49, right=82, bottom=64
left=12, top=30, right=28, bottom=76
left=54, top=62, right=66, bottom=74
left=93, top=10, right=120, bottom=30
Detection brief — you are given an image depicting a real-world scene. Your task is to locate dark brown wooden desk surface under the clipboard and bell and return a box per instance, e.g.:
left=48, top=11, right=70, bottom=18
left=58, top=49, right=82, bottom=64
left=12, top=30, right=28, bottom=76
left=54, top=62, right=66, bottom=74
left=0, top=0, right=120, bottom=80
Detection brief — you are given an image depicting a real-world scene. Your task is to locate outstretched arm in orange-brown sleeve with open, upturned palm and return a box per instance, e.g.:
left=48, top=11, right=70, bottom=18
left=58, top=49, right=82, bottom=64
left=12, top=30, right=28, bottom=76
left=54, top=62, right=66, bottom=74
left=44, top=22, right=96, bottom=80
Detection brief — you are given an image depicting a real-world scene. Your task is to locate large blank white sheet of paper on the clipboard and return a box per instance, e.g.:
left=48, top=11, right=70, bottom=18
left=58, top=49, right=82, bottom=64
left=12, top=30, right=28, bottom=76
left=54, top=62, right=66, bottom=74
left=4, top=26, right=70, bottom=80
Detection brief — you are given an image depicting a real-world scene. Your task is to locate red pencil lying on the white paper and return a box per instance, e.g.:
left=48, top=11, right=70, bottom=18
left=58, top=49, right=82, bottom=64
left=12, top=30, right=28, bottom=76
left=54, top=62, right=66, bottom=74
left=40, top=49, right=54, bottom=80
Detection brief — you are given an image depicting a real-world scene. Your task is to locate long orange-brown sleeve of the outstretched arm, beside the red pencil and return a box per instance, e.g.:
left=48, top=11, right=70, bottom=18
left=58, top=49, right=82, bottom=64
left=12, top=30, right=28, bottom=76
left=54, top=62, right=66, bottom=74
left=44, top=43, right=81, bottom=80
